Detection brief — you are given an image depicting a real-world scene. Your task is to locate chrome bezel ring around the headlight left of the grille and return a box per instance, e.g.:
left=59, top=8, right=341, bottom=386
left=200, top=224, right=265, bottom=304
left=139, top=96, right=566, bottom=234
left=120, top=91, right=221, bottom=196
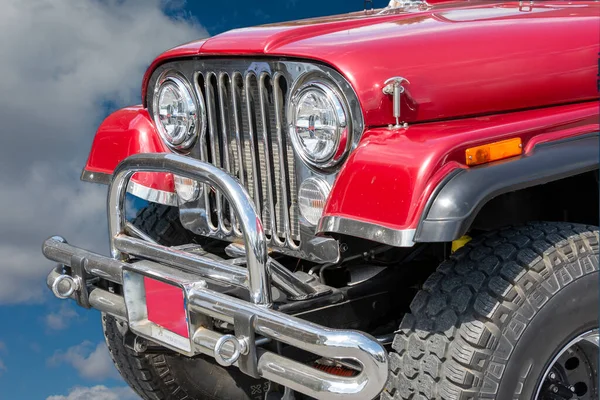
left=152, top=69, right=206, bottom=154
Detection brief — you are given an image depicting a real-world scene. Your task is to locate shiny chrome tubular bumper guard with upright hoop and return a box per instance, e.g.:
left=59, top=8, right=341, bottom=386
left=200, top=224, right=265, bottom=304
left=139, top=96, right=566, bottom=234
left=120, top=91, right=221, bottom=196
left=43, top=154, right=388, bottom=400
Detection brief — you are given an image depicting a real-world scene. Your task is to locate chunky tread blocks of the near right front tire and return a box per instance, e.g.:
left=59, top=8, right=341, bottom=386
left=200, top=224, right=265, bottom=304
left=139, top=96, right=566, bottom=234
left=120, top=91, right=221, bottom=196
left=381, top=222, right=598, bottom=400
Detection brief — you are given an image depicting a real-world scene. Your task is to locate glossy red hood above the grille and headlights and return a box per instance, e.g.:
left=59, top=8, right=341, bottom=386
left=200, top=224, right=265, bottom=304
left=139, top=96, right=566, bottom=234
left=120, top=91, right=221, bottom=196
left=144, top=2, right=600, bottom=126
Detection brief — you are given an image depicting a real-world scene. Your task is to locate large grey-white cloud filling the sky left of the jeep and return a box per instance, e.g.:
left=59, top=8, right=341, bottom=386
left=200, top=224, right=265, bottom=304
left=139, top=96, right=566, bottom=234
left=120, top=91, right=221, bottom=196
left=0, top=0, right=207, bottom=304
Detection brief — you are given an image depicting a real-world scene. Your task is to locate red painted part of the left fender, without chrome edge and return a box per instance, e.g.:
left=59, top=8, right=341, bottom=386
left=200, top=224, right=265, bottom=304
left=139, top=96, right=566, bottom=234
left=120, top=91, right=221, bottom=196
left=85, top=106, right=174, bottom=192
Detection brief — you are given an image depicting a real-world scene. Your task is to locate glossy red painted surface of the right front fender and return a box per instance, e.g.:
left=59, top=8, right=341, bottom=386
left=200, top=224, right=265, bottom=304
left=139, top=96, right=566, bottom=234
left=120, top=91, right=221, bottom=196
left=324, top=102, right=599, bottom=229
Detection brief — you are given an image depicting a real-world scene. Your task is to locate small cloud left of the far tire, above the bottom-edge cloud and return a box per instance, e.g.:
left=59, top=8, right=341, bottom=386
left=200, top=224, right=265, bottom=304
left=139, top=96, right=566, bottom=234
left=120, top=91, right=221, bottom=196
left=47, top=341, right=120, bottom=381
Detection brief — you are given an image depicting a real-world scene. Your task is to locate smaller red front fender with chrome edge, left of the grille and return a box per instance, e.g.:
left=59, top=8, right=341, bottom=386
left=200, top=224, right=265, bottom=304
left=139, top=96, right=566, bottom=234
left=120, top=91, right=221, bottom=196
left=81, top=106, right=177, bottom=205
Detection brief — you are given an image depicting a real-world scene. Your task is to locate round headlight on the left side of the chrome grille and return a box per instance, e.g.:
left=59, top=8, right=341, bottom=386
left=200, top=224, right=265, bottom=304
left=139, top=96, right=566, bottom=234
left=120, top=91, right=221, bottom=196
left=153, top=72, right=202, bottom=150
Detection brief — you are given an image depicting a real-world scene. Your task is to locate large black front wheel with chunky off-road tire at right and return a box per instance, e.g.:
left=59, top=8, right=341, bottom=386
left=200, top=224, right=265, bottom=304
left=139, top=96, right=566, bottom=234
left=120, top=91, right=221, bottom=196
left=381, top=223, right=598, bottom=400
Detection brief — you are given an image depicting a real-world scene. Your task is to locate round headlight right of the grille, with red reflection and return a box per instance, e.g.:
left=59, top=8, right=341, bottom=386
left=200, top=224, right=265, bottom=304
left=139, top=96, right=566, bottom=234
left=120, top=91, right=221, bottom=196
left=290, top=82, right=349, bottom=168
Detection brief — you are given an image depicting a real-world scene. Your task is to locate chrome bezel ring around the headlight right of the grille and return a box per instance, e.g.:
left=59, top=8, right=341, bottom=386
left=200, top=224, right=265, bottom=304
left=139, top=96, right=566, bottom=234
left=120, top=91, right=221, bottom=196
left=287, top=73, right=354, bottom=172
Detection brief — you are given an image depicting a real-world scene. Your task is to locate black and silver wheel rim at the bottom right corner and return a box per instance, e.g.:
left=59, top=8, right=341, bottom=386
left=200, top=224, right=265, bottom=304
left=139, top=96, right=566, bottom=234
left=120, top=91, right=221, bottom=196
left=534, top=329, right=600, bottom=400
